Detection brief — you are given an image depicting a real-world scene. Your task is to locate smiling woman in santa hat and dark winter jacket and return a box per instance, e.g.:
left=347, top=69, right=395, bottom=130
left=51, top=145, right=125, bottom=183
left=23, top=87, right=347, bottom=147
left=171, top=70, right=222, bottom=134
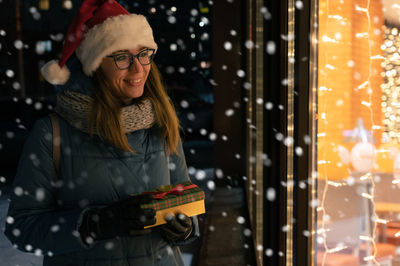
left=5, top=0, right=199, bottom=266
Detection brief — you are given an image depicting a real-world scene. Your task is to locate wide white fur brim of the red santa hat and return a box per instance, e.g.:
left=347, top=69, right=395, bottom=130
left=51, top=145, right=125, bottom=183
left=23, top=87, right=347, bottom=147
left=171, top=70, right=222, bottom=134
left=76, top=14, right=157, bottom=76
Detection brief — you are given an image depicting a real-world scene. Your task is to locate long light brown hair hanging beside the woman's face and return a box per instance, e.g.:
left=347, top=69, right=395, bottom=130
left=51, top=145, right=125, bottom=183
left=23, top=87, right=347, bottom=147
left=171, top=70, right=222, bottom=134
left=89, top=62, right=180, bottom=153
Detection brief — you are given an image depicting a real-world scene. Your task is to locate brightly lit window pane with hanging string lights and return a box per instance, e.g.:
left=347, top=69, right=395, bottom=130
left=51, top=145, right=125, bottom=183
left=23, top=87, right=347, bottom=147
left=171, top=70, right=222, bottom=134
left=314, top=0, right=400, bottom=266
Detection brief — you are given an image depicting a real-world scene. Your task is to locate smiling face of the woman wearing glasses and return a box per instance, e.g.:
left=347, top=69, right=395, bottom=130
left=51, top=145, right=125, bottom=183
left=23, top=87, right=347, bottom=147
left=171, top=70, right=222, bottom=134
left=100, top=47, right=150, bottom=103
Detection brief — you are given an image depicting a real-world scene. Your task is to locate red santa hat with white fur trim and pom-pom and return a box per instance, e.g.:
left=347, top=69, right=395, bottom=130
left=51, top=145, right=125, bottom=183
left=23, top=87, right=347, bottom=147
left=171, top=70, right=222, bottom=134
left=41, top=0, right=157, bottom=85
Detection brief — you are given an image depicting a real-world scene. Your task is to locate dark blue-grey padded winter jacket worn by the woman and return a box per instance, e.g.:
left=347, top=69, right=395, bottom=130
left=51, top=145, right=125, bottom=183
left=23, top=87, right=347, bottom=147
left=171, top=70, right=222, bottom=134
left=5, top=56, right=199, bottom=266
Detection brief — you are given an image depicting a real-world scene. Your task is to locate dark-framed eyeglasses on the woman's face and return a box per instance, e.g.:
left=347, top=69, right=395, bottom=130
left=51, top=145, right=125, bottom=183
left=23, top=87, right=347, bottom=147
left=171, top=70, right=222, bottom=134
left=107, top=49, right=155, bottom=70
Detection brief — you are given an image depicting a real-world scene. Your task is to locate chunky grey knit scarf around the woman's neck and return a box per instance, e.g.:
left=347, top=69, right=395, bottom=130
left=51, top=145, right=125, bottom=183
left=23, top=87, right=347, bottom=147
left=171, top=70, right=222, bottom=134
left=55, top=90, right=155, bottom=133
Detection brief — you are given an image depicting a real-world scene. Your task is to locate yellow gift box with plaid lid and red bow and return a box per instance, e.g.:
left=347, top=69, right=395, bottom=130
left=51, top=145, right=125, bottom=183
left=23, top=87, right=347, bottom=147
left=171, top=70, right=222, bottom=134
left=140, top=181, right=205, bottom=228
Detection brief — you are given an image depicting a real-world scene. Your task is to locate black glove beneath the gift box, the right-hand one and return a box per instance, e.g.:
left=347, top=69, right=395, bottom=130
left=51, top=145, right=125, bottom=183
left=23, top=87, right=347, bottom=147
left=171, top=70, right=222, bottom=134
left=160, top=213, right=193, bottom=242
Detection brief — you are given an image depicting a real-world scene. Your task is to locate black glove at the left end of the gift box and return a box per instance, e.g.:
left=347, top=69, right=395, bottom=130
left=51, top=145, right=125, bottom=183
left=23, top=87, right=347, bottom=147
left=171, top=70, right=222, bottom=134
left=79, top=195, right=156, bottom=244
